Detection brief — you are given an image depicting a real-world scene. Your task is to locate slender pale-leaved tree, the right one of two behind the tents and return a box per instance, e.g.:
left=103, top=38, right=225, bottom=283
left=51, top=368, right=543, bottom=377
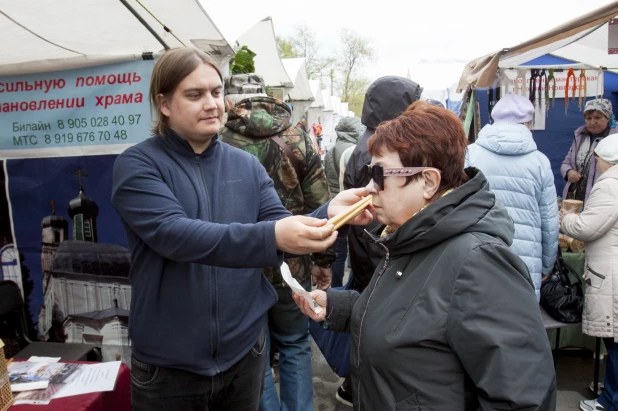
left=339, top=29, right=374, bottom=101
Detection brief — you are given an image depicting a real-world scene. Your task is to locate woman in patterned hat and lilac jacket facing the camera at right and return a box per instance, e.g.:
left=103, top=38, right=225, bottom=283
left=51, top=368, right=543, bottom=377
left=560, top=98, right=617, bottom=203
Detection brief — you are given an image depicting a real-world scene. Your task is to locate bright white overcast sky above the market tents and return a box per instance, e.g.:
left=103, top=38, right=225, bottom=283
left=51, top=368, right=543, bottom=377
left=200, top=0, right=611, bottom=87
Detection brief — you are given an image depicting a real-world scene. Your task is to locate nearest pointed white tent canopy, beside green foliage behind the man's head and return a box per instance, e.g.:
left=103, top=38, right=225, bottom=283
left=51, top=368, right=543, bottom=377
left=236, top=17, right=294, bottom=88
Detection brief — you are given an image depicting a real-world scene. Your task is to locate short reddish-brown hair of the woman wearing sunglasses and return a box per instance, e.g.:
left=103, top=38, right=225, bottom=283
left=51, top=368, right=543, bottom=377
left=367, top=101, right=468, bottom=196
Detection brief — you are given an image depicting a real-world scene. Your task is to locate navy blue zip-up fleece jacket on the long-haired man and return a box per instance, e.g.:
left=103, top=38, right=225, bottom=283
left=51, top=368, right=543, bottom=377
left=112, top=132, right=327, bottom=376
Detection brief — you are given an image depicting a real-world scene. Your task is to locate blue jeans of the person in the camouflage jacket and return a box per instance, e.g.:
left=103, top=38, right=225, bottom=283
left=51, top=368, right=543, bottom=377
left=259, top=280, right=313, bottom=411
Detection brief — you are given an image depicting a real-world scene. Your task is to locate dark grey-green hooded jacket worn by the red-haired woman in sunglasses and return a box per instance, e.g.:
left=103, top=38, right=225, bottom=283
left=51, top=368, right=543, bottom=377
left=326, top=169, right=556, bottom=411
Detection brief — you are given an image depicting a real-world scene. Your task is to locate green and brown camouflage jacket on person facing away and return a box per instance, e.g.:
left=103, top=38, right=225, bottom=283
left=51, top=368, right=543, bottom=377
left=219, top=97, right=335, bottom=285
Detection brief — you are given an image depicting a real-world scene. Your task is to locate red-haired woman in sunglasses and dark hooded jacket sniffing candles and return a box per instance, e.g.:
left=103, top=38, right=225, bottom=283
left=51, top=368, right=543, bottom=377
left=295, top=102, right=556, bottom=411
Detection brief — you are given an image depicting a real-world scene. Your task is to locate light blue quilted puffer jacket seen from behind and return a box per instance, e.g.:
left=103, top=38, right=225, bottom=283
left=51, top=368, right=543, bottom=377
left=466, top=123, right=559, bottom=300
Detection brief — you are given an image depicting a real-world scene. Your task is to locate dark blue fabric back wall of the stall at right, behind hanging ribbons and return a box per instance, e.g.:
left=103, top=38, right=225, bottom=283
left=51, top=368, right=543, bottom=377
left=475, top=55, right=618, bottom=195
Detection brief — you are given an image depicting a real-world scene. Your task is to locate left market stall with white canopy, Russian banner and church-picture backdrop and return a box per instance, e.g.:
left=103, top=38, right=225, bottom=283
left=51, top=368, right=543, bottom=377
left=0, top=0, right=233, bottom=362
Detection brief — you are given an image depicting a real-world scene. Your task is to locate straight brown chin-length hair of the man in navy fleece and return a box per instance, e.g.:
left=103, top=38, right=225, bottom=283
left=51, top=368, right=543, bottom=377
left=150, top=47, right=223, bottom=134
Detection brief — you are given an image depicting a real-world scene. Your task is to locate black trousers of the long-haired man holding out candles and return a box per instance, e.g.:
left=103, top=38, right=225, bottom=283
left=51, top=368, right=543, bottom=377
left=131, top=335, right=267, bottom=411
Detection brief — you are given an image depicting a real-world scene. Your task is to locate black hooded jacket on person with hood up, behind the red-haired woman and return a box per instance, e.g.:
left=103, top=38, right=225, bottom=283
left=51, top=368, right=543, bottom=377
left=343, top=76, right=423, bottom=291
